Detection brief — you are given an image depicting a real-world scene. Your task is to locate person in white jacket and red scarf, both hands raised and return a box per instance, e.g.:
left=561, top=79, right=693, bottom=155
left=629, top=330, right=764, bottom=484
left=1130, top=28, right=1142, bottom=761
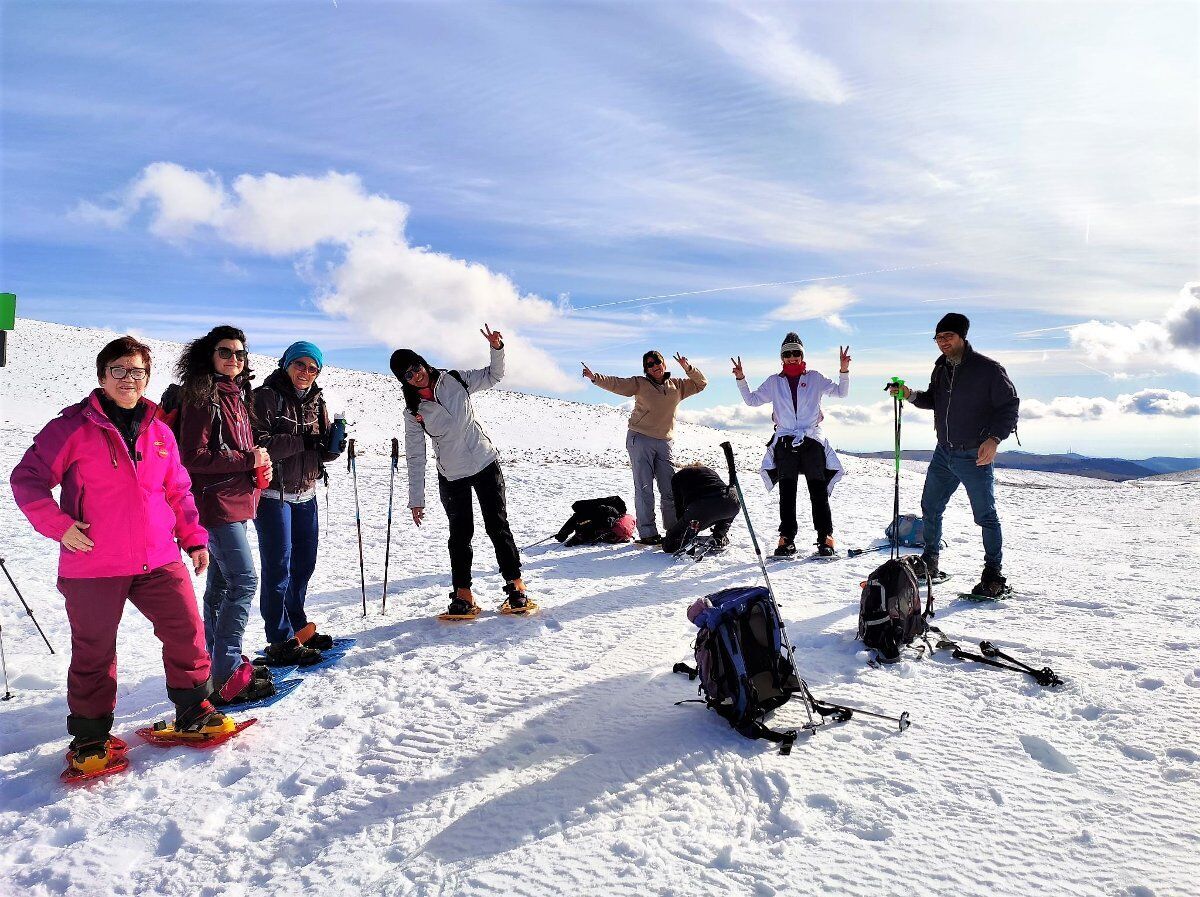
left=730, top=333, right=850, bottom=558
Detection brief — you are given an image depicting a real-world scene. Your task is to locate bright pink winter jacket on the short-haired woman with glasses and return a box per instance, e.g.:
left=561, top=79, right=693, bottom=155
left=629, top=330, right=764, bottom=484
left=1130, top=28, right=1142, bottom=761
left=11, top=390, right=209, bottom=579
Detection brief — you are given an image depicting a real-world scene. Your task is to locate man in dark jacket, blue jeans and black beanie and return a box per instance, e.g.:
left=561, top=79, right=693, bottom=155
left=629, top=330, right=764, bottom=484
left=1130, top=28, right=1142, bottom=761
left=889, top=312, right=1020, bottom=598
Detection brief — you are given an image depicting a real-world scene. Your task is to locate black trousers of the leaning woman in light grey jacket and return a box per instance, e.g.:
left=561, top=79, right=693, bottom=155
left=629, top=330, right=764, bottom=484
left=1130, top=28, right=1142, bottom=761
left=438, top=460, right=521, bottom=589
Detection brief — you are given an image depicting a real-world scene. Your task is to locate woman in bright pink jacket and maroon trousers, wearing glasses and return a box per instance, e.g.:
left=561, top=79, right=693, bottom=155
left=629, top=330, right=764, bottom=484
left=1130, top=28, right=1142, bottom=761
left=12, top=336, right=234, bottom=773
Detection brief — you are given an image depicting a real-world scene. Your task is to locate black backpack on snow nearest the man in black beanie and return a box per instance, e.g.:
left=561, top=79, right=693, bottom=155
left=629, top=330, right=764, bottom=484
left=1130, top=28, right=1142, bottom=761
left=858, top=556, right=934, bottom=663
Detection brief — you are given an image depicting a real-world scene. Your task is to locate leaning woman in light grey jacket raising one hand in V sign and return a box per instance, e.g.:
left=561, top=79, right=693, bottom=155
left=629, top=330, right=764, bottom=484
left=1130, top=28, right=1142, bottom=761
left=391, top=324, right=536, bottom=619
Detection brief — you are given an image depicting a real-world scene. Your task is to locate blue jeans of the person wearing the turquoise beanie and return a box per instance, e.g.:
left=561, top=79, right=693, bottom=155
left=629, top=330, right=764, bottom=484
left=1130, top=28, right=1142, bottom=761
left=254, top=496, right=318, bottom=645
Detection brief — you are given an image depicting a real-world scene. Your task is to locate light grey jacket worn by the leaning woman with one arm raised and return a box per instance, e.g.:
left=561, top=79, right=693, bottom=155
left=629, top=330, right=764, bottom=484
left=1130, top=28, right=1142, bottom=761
left=403, top=349, right=504, bottom=507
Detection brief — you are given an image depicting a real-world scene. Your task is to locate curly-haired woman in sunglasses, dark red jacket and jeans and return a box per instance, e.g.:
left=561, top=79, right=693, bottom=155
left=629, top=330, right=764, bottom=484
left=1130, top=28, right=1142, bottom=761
left=175, top=324, right=275, bottom=705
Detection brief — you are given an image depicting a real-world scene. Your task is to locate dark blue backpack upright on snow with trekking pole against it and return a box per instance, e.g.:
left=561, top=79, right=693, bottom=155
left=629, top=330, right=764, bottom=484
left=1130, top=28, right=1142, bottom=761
left=676, top=585, right=803, bottom=753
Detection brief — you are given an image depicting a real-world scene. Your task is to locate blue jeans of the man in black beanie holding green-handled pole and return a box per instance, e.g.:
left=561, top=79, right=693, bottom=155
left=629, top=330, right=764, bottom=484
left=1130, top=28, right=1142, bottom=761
left=920, top=445, right=1004, bottom=571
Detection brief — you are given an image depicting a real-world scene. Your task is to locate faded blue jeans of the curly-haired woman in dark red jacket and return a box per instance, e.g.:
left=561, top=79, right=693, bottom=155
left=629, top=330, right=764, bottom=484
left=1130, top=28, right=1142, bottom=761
left=204, top=520, right=258, bottom=684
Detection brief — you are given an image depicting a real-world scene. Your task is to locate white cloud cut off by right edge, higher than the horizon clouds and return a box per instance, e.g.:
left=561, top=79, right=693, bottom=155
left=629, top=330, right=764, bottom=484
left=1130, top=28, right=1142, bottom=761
left=1067, top=283, right=1200, bottom=373
